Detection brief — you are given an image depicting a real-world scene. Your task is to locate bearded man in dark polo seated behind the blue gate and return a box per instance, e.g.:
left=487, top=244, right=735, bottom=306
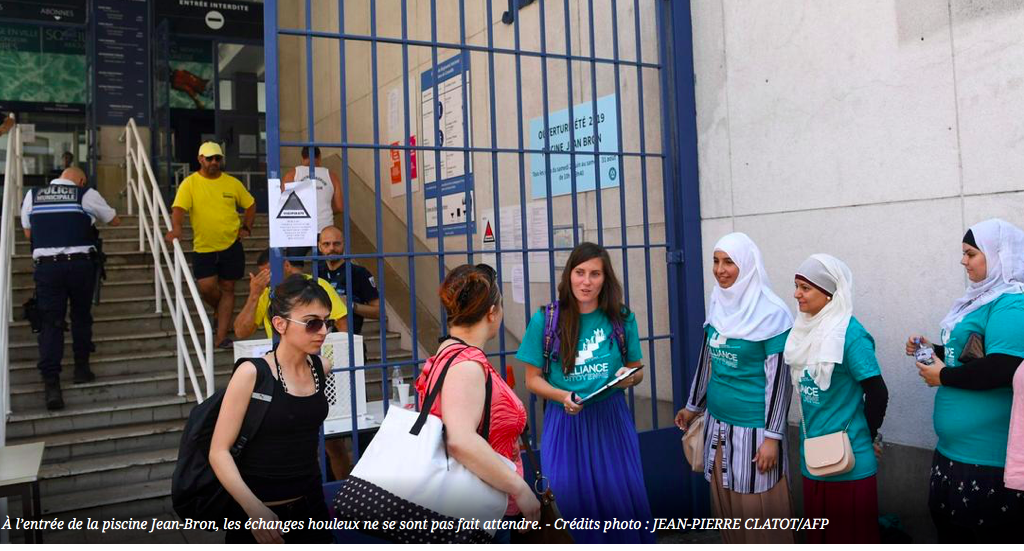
left=316, top=225, right=380, bottom=335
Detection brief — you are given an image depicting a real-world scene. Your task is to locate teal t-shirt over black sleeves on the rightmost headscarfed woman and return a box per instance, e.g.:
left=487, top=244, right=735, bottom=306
left=932, top=294, right=1024, bottom=468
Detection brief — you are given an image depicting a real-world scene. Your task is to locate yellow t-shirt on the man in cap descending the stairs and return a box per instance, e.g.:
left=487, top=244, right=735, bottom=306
left=173, top=172, right=256, bottom=253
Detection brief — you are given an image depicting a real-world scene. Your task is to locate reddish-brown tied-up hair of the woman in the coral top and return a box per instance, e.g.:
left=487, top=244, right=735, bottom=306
left=437, top=264, right=502, bottom=327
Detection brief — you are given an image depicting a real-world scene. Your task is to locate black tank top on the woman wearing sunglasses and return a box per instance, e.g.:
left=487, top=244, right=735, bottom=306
left=234, top=356, right=329, bottom=502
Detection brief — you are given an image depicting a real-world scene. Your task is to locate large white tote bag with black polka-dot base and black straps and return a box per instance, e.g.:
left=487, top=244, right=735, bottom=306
left=335, top=350, right=515, bottom=543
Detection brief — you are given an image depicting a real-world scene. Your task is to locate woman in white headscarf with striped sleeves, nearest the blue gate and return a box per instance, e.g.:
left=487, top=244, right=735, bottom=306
left=676, top=232, right=794, bottom=543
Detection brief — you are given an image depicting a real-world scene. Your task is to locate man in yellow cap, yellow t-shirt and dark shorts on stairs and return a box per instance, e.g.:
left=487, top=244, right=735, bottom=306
left=165, top=141, right=256, bottom=348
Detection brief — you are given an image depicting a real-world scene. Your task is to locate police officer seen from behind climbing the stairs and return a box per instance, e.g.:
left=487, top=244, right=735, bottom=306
left=22, top=167, right=121, bottom=410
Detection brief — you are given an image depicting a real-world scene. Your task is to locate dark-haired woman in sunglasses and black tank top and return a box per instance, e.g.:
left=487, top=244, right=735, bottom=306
left=210, top=274, right=333, bottom=543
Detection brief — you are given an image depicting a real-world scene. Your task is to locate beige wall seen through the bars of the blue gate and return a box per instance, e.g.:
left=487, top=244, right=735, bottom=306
left=280, top=0, right=672, bottom=411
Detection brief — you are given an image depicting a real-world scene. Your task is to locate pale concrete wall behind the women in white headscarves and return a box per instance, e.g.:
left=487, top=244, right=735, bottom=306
left=691, top=0, right=1024, bottom=448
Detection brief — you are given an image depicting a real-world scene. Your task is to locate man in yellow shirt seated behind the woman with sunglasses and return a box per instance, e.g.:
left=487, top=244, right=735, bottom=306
left=234, top=247, right=348, bottom=339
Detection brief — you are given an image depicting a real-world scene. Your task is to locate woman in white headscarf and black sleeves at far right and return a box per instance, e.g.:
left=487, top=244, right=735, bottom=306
left=906, top=219, right=1024, bottom=543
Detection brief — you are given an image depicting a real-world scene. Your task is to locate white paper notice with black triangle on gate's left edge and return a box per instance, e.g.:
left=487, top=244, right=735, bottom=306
left=267, top=178, right=316, bottom=247
